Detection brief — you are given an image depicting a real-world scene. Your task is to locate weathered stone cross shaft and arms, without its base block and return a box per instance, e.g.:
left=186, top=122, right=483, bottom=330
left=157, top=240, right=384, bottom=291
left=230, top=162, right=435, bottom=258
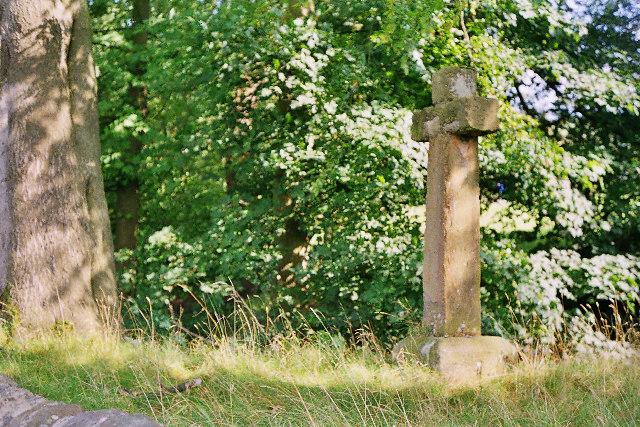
left=412, top=67, right=498, bottom=337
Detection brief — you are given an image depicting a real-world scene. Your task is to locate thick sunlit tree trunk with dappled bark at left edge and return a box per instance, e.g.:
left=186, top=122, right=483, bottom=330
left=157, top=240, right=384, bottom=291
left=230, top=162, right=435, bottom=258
left=0, top=0, right=118, bottom=331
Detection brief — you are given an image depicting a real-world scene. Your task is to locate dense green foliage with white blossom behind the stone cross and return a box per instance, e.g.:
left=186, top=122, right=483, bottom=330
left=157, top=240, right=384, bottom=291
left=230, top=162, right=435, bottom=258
left=92, top=0, right=640, bottom=350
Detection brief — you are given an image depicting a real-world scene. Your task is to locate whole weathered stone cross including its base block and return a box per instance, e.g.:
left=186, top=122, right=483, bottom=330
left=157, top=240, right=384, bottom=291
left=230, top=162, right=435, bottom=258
left=392, top=67, right=517, bottom=384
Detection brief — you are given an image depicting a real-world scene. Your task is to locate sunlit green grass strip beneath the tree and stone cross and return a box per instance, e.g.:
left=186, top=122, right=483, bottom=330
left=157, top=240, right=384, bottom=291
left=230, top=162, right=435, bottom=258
left=0, top=335, right=640, bottom=426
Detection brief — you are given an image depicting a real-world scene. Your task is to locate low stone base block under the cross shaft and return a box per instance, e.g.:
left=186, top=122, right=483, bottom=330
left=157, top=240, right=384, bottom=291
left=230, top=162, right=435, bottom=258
left=392, top=335, right=518, bottom=384
